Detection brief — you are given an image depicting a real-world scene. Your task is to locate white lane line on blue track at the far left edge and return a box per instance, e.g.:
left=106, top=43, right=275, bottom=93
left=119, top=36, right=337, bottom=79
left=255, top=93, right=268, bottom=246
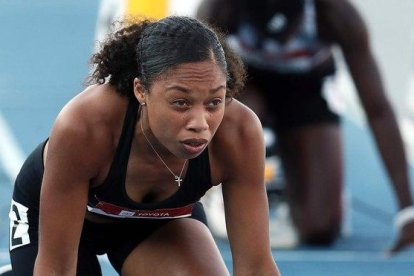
left=0, top=110, right=25, bottom=184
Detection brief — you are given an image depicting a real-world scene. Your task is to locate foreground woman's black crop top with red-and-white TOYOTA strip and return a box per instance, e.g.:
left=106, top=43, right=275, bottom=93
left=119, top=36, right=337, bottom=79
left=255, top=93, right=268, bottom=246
left=87, top=99, right=212, bottom=219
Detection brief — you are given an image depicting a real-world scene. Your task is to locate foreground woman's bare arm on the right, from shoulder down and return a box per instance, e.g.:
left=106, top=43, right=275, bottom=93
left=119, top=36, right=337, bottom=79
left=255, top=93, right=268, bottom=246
left=215, top=100, right=275, bottom=272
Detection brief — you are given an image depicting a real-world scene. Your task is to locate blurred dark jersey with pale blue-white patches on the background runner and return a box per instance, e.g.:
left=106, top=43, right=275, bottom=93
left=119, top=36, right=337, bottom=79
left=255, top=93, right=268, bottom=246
left=228, top=0, right=333, bottom=74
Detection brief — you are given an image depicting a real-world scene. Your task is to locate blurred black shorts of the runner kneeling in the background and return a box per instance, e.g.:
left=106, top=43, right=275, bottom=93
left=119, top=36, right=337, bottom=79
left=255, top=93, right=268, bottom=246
left=246, top=66, right=339, bottom=131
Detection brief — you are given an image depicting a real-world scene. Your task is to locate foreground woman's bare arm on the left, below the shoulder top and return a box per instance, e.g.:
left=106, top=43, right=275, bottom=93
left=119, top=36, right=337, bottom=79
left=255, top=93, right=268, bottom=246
left=38, top=102, right=110, bottom=269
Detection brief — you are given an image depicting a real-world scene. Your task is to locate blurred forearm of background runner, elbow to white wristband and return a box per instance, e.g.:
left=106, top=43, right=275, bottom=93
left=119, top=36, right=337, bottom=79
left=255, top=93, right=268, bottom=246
left=369, top=111, right=413, bottom=209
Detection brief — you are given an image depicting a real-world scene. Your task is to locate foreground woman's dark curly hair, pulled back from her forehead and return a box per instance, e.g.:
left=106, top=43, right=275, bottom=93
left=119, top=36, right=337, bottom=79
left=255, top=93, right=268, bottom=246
left=87, top=16, right=246, bottom=98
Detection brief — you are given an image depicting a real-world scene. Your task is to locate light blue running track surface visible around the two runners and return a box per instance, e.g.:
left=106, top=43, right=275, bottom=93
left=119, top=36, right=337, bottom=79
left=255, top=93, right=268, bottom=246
left=0, top=0, right=414, bottom=275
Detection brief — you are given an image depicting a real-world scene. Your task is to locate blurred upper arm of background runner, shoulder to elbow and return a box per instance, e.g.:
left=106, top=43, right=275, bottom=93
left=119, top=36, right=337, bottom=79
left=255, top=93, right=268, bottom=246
left=318, top=0, right=390, bottom=119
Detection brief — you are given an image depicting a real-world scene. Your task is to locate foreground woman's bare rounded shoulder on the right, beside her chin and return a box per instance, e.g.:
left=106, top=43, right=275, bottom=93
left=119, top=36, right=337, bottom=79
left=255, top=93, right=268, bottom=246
left=210, top=99, right=264, bottom=182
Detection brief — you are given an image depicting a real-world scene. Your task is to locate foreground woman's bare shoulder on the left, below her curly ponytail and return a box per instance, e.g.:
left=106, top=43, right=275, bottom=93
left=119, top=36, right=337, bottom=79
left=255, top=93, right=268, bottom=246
left=47, top=85, right=127, bottom=177
